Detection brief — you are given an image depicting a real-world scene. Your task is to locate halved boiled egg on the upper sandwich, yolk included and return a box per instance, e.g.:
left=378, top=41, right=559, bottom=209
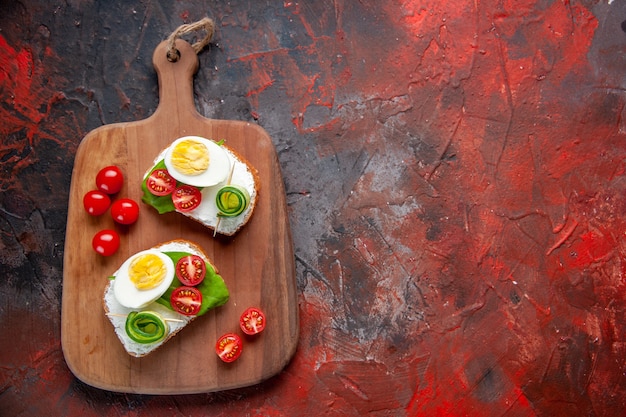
left=164, top=136, right=230, bottom=187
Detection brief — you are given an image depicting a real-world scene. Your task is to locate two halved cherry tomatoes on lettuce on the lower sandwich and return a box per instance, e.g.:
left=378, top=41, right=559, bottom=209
left=170, top=255, right=206, bottom=316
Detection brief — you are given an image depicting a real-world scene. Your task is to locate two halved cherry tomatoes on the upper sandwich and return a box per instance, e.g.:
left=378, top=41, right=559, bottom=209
left=146, top=168, right=202, bottom=213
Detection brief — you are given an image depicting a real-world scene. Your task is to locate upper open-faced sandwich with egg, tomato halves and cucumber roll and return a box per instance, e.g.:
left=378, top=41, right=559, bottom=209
left=142, top=136, right=259, bottom=236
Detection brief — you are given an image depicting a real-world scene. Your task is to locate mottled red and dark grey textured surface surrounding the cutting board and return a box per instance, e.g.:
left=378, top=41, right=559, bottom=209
left=0, top=0, right=626, bottom=417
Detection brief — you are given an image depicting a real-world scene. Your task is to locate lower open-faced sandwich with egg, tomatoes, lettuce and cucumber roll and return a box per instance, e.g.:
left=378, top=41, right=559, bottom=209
left=104, top=239, right=229, bottom=357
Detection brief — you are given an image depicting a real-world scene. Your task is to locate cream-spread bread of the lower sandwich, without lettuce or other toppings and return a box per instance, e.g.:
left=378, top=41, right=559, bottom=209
left=103, top=239, right=228, bottom=357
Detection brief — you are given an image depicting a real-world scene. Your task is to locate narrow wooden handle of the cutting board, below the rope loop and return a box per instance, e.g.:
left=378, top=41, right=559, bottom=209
left=152, top=39, right=199, bottom=123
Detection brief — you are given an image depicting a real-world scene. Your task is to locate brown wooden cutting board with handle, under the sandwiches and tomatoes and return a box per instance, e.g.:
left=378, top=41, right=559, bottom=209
left=61, top=39, right=298, bottom=394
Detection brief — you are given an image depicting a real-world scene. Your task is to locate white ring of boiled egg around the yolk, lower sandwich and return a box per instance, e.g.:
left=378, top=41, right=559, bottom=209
left=113, top=249, right=176, bottom=308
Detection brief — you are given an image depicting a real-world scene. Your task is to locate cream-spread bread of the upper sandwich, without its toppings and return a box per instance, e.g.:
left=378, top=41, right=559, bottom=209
left=142, top=137, right=260, bottom=236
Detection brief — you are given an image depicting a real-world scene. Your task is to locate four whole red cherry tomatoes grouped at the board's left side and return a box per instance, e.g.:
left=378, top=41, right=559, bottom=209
left=83, top=165, right=139, bottom=256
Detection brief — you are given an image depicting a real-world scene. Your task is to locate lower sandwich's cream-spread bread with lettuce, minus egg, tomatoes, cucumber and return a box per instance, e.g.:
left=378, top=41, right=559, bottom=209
left=103, top=239, right=229, bottom=357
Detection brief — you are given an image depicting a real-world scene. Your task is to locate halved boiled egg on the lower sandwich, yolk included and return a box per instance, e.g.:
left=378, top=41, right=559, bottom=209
left=113, top=249, right=176, bottom=308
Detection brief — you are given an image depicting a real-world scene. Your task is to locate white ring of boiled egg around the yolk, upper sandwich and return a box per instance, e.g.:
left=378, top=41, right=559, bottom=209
left=164, top=136, right=230, bottom=187
